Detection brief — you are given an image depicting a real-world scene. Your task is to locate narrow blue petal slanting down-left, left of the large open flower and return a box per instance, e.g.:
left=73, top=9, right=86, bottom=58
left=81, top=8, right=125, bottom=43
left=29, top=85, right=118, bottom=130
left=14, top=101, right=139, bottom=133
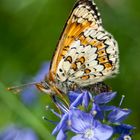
left=52, top=114, right=68, bottom=135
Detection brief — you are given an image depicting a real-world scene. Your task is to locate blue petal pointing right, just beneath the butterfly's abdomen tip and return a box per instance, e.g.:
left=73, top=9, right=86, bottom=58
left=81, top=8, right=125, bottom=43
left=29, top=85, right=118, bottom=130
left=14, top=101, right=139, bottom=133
left=94, top=92, right=116, bottom=104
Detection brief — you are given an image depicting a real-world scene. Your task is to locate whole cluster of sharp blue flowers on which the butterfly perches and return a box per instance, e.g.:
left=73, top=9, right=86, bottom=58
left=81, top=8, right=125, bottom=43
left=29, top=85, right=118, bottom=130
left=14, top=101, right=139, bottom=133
left=46, top=90, right=134, bottom=140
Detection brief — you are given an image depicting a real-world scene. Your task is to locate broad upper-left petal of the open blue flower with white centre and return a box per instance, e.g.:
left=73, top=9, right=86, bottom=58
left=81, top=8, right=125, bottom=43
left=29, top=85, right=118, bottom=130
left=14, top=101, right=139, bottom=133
left=69, top=109, right=93, bottom=133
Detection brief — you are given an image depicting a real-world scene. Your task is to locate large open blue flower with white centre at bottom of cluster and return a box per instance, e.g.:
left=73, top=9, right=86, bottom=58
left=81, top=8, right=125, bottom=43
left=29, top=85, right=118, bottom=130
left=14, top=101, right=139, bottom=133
left=69, top=109, right=113, bottom=140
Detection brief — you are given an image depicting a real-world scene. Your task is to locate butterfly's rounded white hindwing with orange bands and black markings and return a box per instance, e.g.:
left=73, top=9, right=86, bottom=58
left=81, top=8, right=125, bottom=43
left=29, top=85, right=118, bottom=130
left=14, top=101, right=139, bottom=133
left=57, top=30, right=118, bottom=86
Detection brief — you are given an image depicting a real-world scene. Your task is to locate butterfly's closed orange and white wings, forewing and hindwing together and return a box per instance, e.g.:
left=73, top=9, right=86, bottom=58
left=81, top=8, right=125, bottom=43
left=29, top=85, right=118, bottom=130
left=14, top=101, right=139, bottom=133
left=49, top=0, right=118, bottom=87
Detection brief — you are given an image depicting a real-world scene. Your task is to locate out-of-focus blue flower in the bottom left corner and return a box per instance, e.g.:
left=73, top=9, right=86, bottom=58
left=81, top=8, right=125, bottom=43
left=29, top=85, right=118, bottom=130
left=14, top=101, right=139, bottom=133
left=0, top=125, right=38, bottom=140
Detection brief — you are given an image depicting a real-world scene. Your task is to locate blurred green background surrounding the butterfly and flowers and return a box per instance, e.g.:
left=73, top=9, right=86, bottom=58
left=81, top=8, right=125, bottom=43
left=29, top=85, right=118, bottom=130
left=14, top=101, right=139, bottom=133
left=0, top=0, right=140, bottom=140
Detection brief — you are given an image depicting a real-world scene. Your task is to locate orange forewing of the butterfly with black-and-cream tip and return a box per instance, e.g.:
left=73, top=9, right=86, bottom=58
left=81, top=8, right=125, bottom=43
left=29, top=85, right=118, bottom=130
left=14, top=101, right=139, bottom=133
left=51, top=0, right=101, bottom=77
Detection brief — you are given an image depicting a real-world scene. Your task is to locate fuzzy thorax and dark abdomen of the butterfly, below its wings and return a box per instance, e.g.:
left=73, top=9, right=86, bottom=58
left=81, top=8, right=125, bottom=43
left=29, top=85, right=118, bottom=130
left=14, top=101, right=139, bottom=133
left=41, top=72, right=111, bottom=95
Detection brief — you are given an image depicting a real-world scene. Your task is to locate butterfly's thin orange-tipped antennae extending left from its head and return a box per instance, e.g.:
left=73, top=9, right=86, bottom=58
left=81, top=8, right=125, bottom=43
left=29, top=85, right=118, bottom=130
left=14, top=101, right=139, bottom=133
left=7, top=82, right=38, bottom=93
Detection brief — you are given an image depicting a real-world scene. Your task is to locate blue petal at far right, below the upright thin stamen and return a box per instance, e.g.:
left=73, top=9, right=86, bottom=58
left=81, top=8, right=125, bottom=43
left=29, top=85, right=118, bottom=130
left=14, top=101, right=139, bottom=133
left=108, top=108, right=131, bottom=123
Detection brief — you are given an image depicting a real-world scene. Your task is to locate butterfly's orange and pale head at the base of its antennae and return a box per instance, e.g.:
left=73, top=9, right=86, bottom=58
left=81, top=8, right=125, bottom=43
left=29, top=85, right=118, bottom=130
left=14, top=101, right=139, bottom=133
left=35, top=81, right=51, bottom=94
